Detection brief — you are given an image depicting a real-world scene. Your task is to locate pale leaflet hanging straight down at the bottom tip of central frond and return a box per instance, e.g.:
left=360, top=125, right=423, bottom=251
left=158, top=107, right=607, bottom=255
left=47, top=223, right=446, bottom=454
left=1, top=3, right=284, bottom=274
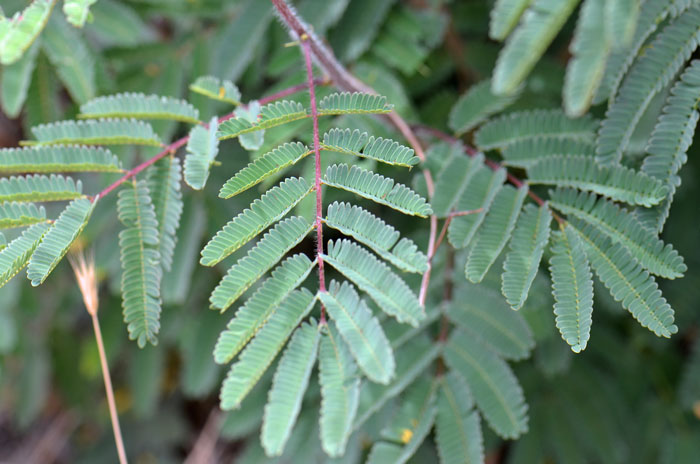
left=318, top=324, right=360, bottom=457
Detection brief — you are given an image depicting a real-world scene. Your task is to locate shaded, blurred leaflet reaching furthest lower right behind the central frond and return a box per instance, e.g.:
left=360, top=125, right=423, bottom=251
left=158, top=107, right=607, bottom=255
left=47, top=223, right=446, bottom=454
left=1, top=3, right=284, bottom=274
left=444, top=331, right=527, bottom=439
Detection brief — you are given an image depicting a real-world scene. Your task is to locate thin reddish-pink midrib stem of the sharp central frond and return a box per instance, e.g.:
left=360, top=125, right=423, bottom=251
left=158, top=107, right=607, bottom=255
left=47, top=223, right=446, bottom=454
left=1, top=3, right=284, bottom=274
left=300, top=35, right=326, bottom=324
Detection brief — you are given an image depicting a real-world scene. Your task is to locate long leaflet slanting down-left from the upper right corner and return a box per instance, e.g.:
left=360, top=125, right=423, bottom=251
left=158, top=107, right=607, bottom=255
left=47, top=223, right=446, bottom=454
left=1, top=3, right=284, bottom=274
left=596, top=6, right=700, bottom=165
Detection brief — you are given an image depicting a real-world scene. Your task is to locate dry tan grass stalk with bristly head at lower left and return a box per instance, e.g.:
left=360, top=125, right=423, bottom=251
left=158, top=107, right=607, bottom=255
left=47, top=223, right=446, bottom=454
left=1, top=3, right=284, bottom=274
left=69, top=253, right=127, bottom=464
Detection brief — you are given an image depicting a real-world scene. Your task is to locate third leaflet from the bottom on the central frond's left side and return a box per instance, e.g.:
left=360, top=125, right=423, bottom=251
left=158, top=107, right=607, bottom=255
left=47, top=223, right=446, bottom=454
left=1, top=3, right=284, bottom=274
left=214, top=254, right=316, bottom=364
